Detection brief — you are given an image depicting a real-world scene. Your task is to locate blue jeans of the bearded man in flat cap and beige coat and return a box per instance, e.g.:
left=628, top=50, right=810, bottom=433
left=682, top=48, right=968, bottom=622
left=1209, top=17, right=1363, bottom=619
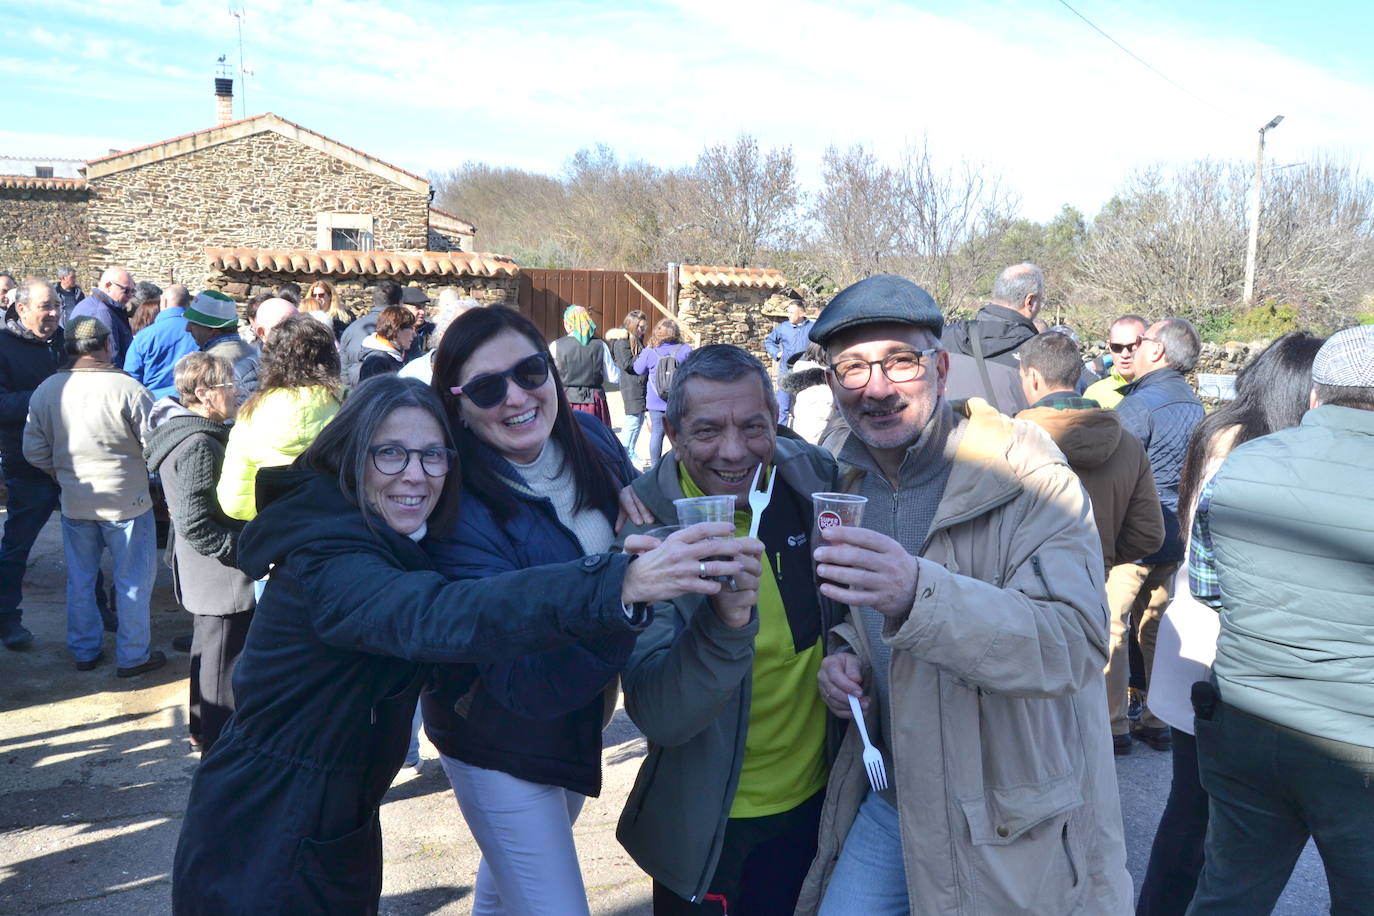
left=820, top=792, right=911, bottom=916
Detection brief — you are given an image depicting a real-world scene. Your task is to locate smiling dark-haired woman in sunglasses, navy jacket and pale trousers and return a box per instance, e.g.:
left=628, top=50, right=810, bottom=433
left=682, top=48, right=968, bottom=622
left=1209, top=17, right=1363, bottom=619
left=422, top=309, right=738, bottom=916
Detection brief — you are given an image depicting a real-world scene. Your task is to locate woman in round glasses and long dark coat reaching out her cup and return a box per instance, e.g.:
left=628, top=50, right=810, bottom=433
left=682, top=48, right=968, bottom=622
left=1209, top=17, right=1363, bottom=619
left=172, top=373, right=741, bottom=916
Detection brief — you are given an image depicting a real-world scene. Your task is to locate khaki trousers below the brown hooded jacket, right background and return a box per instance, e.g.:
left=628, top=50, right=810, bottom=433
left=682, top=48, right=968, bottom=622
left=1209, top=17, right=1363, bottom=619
left=1105, top=563, right=1179, bottom=735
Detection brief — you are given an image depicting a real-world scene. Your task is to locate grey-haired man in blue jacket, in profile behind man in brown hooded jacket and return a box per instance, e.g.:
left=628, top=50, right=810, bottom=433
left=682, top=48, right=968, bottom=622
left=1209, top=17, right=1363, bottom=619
left=1107, top=319, right=1205, bottom=751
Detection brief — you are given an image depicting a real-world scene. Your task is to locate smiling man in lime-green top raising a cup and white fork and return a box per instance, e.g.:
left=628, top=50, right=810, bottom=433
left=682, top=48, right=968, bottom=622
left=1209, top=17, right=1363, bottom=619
left=617, top=345, right=835, bottom=916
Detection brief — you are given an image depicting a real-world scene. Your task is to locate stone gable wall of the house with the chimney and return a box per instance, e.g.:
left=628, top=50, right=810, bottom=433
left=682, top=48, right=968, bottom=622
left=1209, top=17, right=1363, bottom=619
left=89, top=130, right=429, bottom=288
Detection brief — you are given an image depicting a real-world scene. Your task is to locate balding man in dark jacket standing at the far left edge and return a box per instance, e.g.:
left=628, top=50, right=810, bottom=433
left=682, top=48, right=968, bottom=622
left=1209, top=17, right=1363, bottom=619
left=0, top=280, right=66, bottom=650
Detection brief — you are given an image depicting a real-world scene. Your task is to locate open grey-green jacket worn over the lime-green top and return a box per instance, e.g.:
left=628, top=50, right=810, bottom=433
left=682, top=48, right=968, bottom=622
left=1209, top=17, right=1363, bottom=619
left=616, top=438, right=838, bottom=901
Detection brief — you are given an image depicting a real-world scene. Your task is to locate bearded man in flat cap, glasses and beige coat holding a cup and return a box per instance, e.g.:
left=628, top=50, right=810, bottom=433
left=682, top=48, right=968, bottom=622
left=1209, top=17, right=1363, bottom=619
left=797, top=275, right=1132, bottom=916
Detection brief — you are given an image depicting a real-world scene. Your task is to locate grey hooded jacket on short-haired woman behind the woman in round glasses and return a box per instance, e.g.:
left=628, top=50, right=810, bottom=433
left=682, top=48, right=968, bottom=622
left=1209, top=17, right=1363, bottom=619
left=143, top=398, right=253, bottom=617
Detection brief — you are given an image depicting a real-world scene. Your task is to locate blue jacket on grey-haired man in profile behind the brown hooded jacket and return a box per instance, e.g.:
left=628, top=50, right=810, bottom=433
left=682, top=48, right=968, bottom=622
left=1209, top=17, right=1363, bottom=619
left=1117, top=367, right=1206, bottom=563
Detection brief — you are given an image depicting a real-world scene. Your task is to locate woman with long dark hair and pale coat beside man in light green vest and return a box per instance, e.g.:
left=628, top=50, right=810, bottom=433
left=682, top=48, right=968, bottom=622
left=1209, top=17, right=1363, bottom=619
left=1136, top=331, right=1325, bottom=916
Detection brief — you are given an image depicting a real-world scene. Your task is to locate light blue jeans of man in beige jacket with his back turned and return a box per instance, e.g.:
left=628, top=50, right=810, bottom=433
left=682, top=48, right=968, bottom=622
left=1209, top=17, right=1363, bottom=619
left=62, top=509, right=158, bottom=667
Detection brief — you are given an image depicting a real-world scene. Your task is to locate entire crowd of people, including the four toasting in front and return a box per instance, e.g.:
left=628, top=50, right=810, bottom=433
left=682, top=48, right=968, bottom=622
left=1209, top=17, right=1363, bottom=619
left=0, top=264, right=1374, bottom=916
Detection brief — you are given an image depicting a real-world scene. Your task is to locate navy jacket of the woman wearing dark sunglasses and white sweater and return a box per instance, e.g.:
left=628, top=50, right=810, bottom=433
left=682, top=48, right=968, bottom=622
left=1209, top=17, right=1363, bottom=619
left=422, top=412, right=636, bottom=795
